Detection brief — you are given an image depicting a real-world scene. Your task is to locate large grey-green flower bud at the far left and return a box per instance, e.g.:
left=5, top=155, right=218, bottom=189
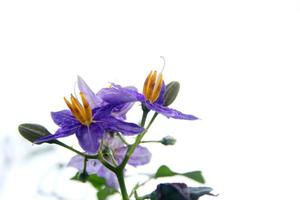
left=19, top=124, right=53, bottom=144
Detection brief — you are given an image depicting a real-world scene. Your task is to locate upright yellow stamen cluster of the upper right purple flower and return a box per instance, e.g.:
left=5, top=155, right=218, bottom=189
left=143, top=71, right=163, bottom=103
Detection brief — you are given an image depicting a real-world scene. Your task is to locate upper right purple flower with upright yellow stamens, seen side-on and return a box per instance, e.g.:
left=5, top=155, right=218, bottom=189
left=97, top=71, right=198, bottom=120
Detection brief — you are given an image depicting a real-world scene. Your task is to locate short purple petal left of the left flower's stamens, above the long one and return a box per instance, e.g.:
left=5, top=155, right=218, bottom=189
left=51, top=110, right=79, bottom=127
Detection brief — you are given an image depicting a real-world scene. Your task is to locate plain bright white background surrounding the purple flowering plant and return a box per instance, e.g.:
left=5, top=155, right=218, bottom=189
left=0, top=0, right=300, bottom=200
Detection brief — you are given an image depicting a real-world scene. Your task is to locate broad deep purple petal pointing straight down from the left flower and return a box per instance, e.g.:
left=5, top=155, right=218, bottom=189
left=76, top=123, right=104, bottom=153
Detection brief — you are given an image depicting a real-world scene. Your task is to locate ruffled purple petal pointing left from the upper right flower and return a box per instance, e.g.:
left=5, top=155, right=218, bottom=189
left=97, top=84, right=144, bottom=104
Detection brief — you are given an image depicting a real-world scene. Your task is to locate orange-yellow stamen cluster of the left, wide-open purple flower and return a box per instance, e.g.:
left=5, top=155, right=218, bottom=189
left=64, top=92, right=92, bottom=126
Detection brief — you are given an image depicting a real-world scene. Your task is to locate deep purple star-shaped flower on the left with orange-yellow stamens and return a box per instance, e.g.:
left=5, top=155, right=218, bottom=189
left=35, top=92, right=143, bottom=153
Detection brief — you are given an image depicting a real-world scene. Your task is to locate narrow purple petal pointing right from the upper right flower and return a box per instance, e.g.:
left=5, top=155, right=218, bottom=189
left=145, top=102, right=198, bottom=120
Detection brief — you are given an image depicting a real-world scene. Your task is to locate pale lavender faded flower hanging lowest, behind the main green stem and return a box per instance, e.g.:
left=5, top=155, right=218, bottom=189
left=68, top=134, right=151, bottom=189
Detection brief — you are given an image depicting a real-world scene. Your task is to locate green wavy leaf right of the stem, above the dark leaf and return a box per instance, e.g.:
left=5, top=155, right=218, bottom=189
left=154, top=165, right=205, bottom=183
